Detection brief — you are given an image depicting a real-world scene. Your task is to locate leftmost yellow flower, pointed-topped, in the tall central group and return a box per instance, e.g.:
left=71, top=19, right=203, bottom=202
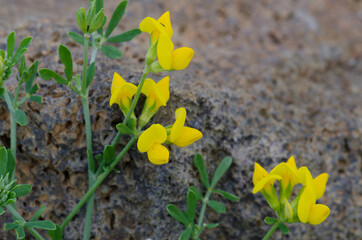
left=109, top=72, right=137, bottom=111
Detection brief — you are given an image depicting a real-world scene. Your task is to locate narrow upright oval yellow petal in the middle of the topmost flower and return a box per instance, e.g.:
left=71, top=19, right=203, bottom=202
left=157, top=33, right=174, bottom=70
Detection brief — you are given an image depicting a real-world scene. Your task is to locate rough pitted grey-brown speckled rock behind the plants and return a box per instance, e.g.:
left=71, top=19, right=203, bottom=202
left=0, top=0, right=362, bottom=240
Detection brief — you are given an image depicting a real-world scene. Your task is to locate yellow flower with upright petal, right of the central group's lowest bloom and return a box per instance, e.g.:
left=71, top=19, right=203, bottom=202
left=167, top=107, right=202, bottom=147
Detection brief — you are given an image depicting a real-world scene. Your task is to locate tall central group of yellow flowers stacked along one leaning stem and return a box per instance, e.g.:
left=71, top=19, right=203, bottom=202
left=110, top=12, right=203, bottom=165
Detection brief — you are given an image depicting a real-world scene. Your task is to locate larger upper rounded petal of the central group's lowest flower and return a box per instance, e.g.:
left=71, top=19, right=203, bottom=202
left=137, top=124, right=167, bottom=152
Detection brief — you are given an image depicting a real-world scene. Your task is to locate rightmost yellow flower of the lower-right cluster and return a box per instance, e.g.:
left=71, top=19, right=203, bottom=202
left=298, top=167, right=330, bottom=225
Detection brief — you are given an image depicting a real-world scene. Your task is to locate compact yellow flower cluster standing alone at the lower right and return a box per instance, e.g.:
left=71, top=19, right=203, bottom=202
left=253, top=156, right=330, bottom=225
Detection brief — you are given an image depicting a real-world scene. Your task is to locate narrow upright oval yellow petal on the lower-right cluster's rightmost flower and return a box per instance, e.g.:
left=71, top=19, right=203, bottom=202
left=297, top=186, right=316, bottom=223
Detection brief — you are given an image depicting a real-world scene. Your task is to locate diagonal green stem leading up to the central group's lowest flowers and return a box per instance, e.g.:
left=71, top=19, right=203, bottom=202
left=60, top=137, right=137, bottom=230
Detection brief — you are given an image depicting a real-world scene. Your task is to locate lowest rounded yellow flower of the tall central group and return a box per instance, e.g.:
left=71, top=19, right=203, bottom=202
left=137, top=124, right=169, bottom=165
